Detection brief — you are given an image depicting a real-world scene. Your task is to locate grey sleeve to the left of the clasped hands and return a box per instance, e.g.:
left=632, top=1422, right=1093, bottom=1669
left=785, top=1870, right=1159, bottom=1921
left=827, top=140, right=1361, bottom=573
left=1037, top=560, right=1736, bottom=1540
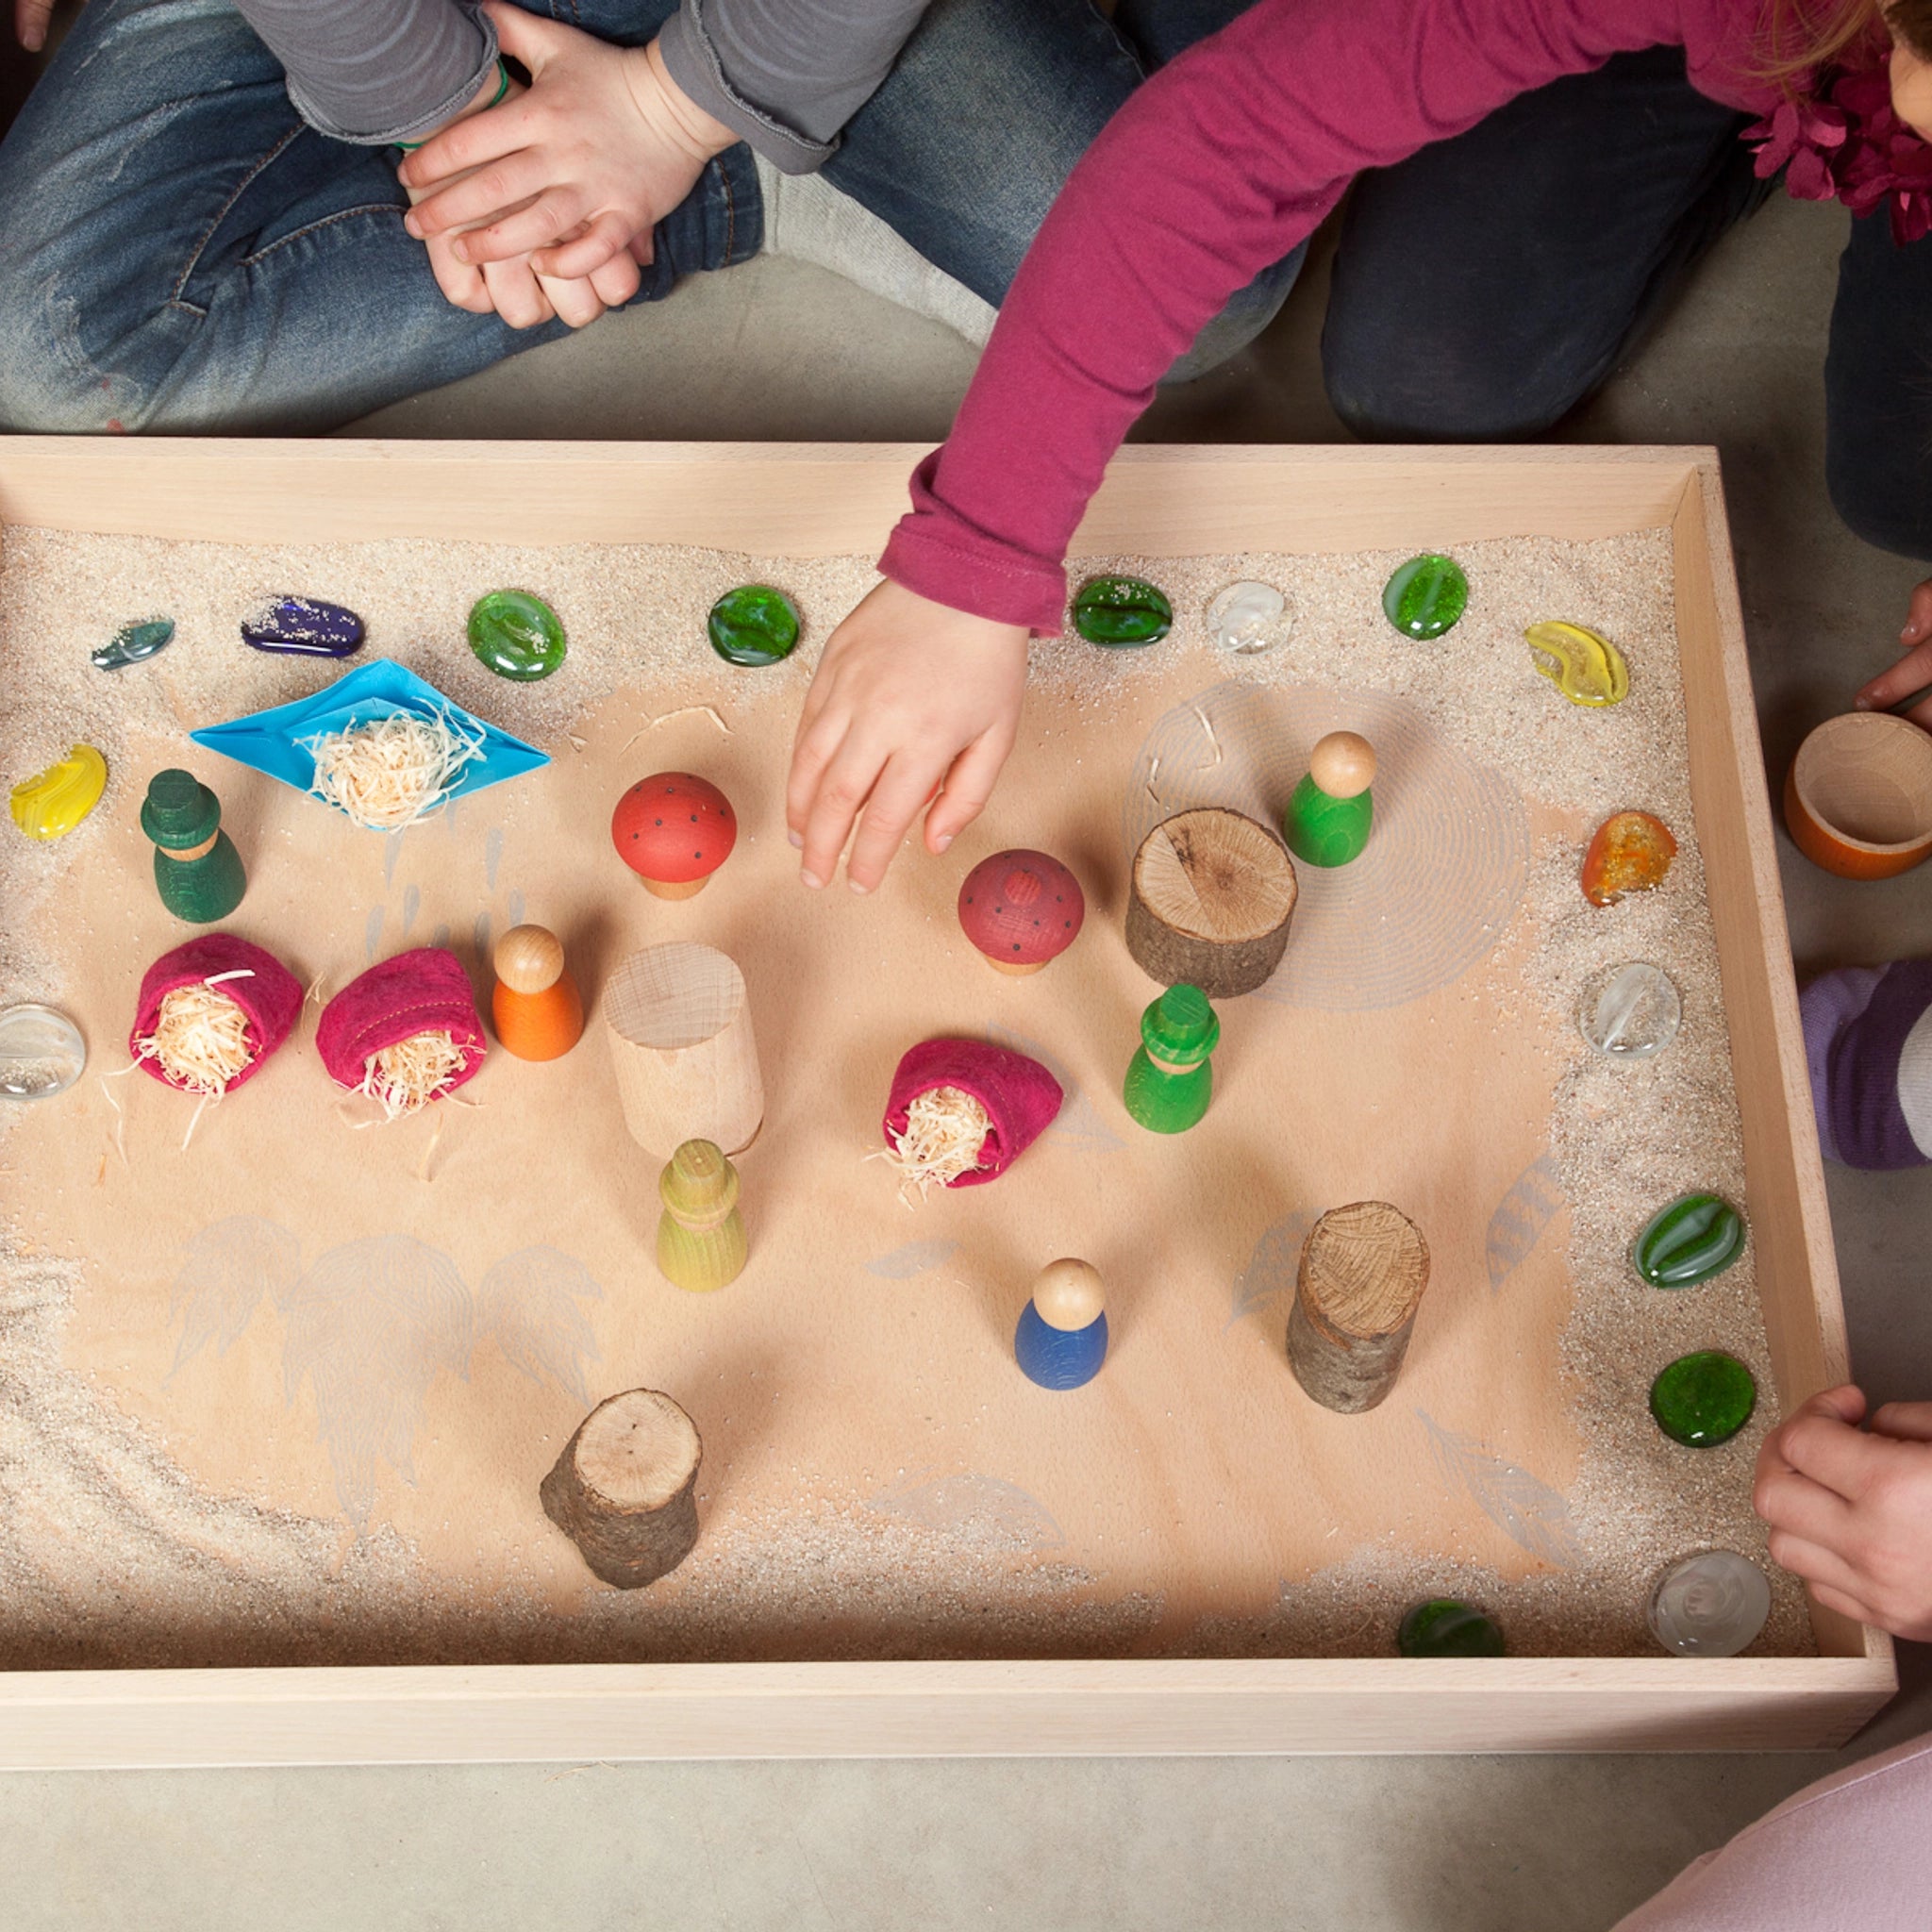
left=236, top=0, right=496, bottom=147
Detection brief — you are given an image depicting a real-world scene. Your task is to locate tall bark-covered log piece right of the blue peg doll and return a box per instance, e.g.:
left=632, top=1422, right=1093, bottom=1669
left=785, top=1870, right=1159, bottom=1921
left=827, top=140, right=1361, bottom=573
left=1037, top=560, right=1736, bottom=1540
left=1289, top=1202, right=1430, bottom=1416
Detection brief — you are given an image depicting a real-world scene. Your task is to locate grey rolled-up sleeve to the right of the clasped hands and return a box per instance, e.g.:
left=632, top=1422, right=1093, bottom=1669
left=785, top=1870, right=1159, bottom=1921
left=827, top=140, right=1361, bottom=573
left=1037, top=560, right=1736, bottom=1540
left=658, top=0, right=927, bottom=174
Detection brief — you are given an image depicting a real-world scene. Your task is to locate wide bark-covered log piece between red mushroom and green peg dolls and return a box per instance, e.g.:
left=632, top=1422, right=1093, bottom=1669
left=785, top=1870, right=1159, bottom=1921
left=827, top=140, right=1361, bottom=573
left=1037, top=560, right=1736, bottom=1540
left=1126, top=806, right=1296, bottom=999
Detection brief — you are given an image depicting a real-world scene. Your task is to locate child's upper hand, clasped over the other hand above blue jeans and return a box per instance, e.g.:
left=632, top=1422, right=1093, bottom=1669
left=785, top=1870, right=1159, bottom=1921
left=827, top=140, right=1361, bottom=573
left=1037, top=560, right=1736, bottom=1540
left=402, top=0, right=738, bottom=288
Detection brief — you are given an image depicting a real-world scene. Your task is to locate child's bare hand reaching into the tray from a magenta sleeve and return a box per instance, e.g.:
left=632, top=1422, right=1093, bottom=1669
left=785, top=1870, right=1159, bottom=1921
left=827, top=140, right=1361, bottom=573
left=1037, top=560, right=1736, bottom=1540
left=784, top=581, right=1028, bottom=892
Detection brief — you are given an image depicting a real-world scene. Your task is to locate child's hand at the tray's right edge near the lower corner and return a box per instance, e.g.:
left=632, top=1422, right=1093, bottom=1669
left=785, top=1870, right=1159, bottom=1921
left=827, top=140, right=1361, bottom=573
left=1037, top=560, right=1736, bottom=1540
left=1750, top=1387, right=1932, bottom=1642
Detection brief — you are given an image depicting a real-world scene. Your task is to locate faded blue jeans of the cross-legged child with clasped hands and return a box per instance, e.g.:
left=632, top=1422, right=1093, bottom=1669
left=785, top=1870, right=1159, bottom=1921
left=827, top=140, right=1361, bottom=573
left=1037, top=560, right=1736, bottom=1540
left=0, top=0, right=1298, bottom=433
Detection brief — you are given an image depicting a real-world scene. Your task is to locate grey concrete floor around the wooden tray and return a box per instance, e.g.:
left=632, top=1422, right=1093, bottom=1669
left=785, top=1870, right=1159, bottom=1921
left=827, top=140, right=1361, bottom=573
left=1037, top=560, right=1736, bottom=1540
left=0, top=26, right=1932, bottom=1932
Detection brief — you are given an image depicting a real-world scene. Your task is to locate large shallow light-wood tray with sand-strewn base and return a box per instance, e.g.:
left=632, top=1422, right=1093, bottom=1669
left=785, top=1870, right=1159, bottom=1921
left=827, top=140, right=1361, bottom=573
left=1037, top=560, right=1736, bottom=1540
left=0, top=439, right=1893, bottom=1764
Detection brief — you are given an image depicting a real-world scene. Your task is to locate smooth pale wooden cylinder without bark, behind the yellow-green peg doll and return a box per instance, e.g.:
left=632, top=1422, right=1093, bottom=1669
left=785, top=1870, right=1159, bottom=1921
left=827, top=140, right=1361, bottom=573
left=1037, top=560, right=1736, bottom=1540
left=605, top=941, right=765, bottom=1161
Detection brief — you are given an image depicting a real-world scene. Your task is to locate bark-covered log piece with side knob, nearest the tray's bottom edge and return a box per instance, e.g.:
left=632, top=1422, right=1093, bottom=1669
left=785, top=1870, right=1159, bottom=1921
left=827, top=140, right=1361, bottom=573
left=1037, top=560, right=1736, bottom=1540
left=537, top=1390, right=703, bottom=1591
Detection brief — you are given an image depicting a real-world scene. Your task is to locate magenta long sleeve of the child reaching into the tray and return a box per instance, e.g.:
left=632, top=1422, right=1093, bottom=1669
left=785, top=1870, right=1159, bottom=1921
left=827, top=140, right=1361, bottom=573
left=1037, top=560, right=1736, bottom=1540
left=879, top=0, right=1777, bottom=632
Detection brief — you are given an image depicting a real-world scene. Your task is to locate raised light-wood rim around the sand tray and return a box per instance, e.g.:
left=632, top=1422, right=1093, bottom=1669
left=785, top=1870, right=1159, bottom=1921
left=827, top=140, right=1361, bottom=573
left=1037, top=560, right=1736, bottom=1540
left=0, top=437, right=1897, bottom=1768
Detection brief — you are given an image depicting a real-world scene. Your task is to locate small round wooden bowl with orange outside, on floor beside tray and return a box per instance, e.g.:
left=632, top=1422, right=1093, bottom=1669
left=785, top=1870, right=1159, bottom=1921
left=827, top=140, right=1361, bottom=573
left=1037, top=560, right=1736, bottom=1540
left=1785, top=711, right=1932, bottom=879
